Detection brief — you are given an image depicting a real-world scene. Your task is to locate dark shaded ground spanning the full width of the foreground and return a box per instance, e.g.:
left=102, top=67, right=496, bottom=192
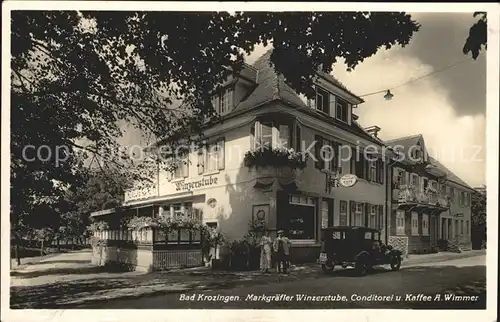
left=11, top=266, right=486, bottom=309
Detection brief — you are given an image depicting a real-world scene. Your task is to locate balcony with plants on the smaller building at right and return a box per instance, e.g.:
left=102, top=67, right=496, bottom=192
left=393, top=185, right=450, bottom=208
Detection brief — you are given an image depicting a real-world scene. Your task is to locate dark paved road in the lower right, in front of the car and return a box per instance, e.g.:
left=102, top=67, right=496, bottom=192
left=82, top=255, right=486, bottom=309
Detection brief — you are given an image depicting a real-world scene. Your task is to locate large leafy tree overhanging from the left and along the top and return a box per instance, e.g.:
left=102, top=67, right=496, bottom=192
left=11, top=11, right=419, bottom=249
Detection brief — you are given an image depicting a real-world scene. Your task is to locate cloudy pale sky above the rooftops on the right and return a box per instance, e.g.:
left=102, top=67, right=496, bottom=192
left=119, top=13, right=486, bottom=187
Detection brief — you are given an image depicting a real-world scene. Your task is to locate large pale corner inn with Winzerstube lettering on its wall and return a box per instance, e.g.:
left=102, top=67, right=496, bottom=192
left=91, top=51, right=390, bottom=268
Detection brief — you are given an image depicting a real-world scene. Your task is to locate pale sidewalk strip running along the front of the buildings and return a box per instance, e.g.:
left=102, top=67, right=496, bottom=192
left=10, top=251, right=485, bottom=309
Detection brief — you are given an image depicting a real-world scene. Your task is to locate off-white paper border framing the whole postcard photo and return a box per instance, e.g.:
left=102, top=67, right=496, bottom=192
left=1, top=1, right=500, bottom=322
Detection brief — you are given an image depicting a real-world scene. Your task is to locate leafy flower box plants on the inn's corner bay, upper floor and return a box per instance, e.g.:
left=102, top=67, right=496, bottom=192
left=243, top=146, right=308, bottom=169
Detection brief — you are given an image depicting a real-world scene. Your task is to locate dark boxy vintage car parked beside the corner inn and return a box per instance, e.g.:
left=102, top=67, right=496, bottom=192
left=318, top=226, right=402, bottom=275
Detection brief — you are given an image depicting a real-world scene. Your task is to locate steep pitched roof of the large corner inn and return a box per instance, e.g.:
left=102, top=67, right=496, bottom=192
left=232, top=49, right=384, bottom=145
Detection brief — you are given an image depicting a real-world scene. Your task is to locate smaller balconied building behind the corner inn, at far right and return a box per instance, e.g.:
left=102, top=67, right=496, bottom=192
left=386, top=134, right=474, bottom=253
